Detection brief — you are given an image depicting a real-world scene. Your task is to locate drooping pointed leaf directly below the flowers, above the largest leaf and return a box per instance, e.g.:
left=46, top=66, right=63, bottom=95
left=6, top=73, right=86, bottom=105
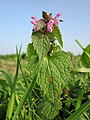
left=32, top=31, right=50, bottom=60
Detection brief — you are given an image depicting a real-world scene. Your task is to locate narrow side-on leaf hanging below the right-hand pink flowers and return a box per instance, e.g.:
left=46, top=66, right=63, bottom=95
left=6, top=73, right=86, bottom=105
left=53, top=26, right=63, bottom=48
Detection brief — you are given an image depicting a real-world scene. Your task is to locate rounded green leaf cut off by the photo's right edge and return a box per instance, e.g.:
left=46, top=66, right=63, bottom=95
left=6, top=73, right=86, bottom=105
left=81, top=44, right=90, bottom=68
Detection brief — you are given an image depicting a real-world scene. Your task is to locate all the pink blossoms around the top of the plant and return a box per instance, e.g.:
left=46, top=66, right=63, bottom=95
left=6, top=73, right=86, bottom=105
left=31, top=13, right=61, bottom=32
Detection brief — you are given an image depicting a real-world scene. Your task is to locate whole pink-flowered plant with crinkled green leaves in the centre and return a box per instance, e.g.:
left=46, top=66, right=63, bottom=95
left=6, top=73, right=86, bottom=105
left=27, top=11, right=71, bottom=120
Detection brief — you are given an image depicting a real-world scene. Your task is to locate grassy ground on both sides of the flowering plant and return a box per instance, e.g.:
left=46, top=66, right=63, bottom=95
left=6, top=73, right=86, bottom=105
left=0, top=54, right=90, bottom=120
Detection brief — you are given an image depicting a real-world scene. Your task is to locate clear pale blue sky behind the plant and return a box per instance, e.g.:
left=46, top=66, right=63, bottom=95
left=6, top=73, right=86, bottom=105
left=0, top=0, right=90, bottom=55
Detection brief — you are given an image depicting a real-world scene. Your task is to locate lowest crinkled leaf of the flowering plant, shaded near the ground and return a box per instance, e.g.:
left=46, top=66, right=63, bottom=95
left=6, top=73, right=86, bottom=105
left=36, top=100, right=62, bottom=120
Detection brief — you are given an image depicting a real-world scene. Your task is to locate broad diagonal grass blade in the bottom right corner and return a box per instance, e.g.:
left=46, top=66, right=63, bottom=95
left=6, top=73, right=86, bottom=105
left=66, top=100, right=90, bottom=120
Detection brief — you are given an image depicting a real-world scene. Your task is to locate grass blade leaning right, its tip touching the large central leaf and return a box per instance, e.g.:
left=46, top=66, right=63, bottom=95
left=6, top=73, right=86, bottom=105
left=12, top=76, right=36, bottom=120
